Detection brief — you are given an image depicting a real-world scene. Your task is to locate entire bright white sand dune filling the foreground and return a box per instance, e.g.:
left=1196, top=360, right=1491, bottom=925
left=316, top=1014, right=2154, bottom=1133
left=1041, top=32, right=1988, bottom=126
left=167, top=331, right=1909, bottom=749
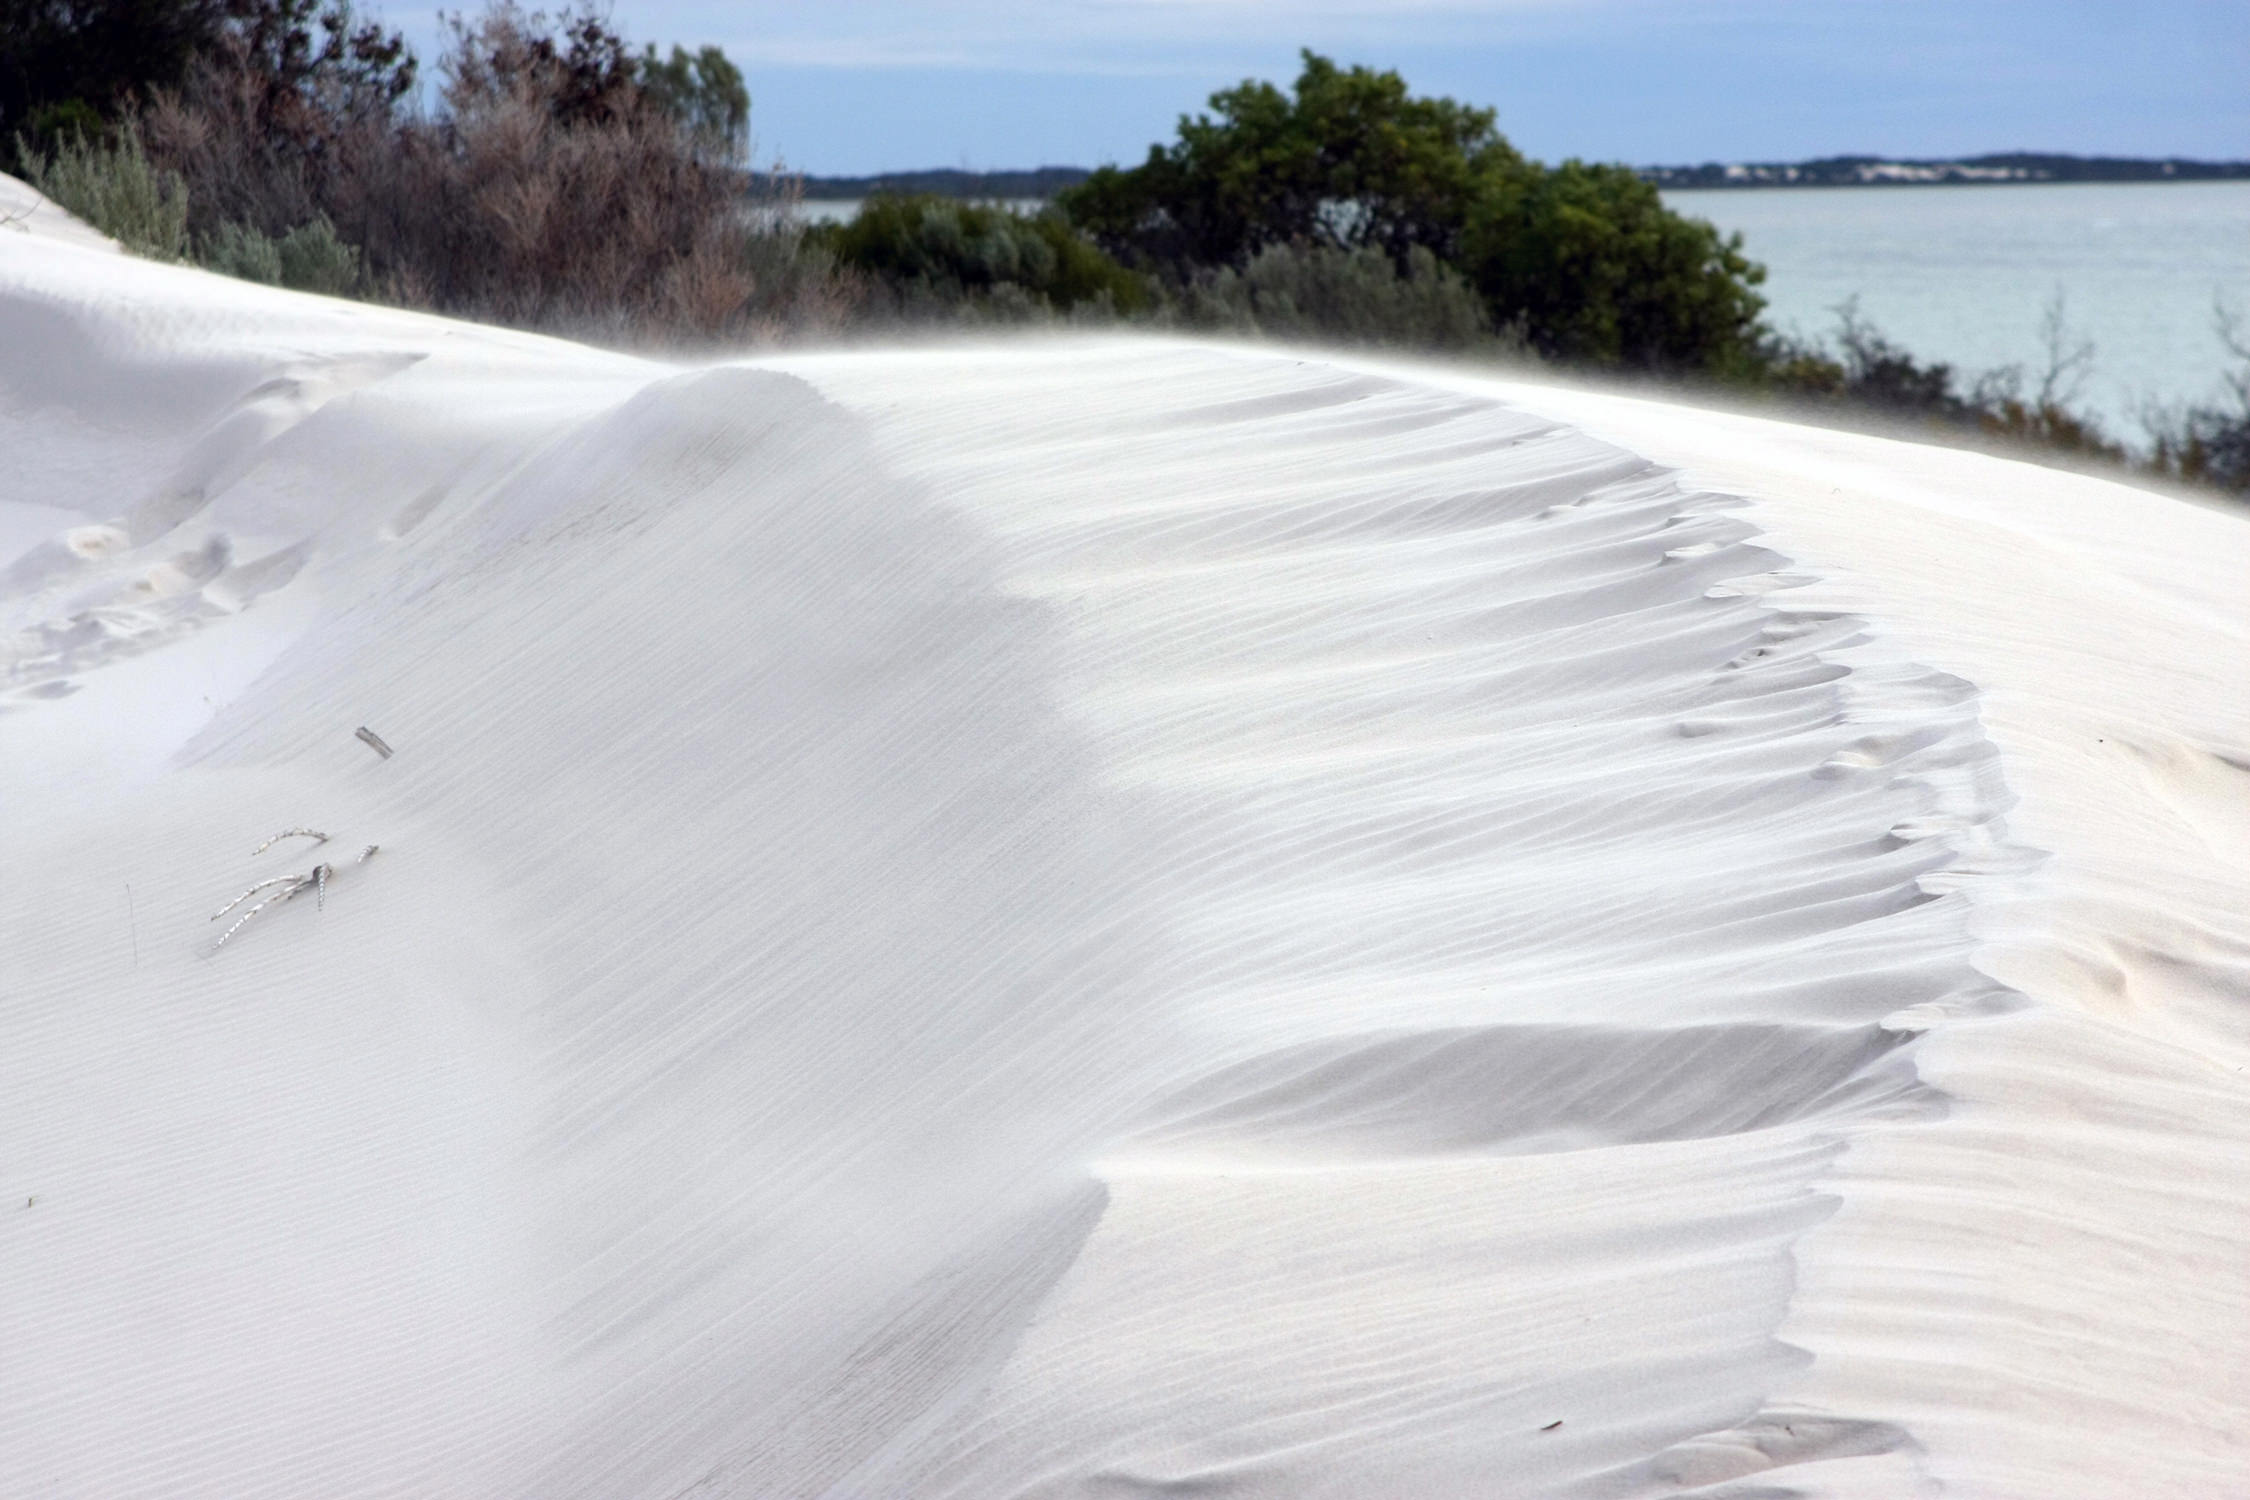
left=13, top=191, right=2250, bottom=1500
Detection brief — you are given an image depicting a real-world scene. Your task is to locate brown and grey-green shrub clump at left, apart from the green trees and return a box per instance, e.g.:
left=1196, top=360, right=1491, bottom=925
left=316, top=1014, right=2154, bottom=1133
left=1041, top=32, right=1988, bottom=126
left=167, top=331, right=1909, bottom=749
left=0, top=0, right=855, bottom=342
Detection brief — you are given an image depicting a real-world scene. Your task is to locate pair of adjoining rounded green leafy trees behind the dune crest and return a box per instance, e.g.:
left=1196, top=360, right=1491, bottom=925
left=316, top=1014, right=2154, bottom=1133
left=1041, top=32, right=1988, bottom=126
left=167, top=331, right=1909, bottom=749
left=1062, top=52, right=1764, bottom=373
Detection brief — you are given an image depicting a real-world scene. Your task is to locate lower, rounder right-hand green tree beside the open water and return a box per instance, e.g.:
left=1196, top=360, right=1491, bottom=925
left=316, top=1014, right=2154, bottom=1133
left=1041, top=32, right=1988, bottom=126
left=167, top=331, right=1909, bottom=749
left=1460, top=162, right=1766, bottom=373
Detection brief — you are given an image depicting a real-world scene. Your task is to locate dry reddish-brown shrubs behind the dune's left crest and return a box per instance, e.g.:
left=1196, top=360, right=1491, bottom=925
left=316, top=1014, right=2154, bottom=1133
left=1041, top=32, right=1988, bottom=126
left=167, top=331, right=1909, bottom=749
left=146, top=4, right=857, bottom=344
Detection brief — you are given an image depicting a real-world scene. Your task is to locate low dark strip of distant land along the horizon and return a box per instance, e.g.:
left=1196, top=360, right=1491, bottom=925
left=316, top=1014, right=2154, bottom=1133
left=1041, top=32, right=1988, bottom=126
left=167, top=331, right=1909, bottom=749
left=778, top=151, right=2250, bottom=202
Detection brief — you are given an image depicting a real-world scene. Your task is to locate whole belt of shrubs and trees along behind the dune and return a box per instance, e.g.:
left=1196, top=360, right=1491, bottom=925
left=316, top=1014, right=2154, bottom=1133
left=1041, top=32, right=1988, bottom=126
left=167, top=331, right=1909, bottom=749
left=0, top=11, right=2250, bottom=493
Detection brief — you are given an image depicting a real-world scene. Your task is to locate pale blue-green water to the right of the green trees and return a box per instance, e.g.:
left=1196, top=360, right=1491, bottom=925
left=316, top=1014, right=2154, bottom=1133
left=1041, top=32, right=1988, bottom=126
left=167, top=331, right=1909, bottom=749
left=1665, top=182, right=2250, bottom=439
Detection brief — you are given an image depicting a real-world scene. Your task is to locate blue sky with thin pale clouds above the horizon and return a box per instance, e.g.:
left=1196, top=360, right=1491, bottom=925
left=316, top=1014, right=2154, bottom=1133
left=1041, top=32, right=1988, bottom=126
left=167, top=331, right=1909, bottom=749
left=389, top=0, right=2250, bottom=173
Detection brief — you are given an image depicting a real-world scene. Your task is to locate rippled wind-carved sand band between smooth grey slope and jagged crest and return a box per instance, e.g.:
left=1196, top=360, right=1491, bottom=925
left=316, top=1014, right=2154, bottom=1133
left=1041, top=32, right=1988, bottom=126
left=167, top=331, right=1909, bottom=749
left=774, top=349, right=2027, bottom=1493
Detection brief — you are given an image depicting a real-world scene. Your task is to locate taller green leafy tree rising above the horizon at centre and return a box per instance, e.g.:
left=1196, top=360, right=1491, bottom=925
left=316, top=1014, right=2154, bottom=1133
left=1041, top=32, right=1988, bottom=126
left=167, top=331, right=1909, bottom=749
left=1060, top=52, right=1523, bottom=268
